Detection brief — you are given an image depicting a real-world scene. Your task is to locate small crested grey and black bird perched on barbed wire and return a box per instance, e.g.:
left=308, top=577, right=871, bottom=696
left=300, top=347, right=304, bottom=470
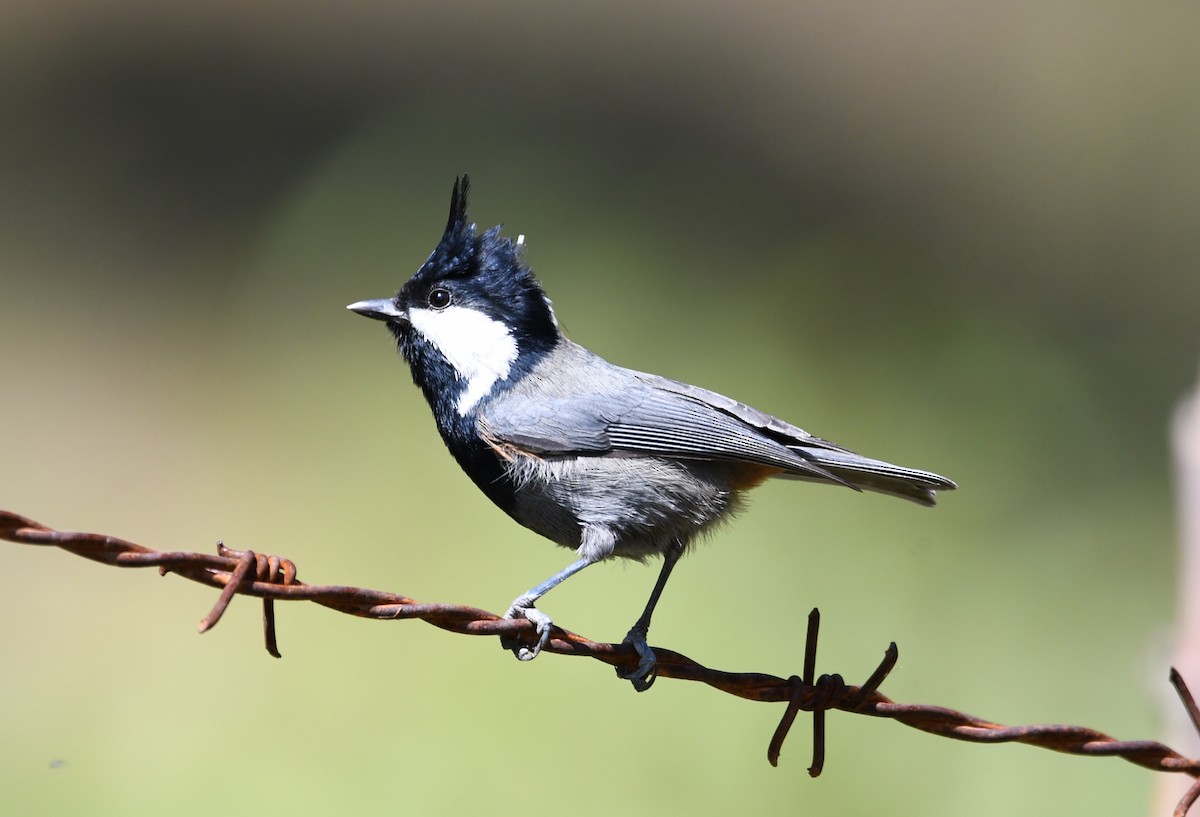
left=347, top=174, right=956, bottom=691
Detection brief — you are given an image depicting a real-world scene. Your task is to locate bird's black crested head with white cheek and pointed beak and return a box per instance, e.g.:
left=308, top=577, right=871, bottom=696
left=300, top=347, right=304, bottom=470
left=347, top=175, right=560, bottom=416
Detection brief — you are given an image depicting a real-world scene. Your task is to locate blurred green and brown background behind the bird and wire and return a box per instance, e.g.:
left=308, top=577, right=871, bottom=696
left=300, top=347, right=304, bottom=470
left=0, top=0, right=1200, bottom=816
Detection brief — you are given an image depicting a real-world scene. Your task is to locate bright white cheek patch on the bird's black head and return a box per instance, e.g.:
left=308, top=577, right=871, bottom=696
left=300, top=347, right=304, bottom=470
left=408, top=306, right=517, bottom=415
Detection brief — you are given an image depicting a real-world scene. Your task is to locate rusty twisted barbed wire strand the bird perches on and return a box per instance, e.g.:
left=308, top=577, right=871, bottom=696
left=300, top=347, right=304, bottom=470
left=7, top=510, right=1200, bottom=817
